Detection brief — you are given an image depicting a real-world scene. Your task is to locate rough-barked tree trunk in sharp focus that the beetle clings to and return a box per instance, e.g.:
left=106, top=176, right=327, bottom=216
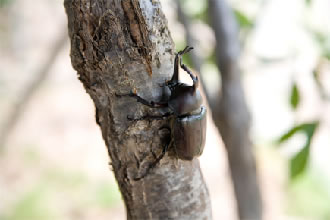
left=64, top=0, right=211, bottom=219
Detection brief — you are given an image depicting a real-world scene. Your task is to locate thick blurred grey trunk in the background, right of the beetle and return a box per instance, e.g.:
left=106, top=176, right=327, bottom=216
left=209, top=0, right=262, bottom=220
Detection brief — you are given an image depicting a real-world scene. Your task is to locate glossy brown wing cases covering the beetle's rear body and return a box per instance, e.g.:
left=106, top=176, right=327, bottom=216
left=171, top=106, right=206, bottom=160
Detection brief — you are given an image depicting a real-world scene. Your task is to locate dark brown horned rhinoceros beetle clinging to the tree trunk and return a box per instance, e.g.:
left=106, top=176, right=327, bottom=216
left=118, top=46, right=206, bottom=165
